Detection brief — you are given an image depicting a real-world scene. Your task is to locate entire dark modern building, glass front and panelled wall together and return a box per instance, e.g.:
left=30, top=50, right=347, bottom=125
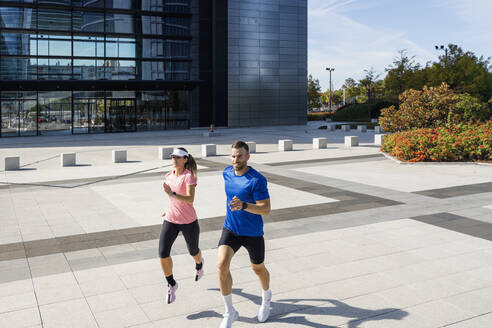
left=0, top=0, right=307, bottom=137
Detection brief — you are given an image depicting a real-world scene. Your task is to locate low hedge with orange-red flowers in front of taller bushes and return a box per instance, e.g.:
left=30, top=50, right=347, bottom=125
left=381, top=117, right=492, bottom=162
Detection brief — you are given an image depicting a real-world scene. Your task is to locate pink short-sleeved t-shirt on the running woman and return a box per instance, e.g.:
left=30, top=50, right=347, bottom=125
left=165, top=170, right=197, bottom=224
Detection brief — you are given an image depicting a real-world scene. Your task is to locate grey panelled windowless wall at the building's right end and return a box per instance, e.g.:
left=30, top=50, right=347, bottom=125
left=228, top=0, right=307, bottom=127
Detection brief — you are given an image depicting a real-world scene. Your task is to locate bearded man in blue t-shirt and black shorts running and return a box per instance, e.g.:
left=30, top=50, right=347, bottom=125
left=217, top=141, right=272, bottom=328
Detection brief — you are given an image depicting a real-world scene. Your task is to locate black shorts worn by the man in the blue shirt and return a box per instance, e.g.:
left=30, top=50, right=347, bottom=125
left=219, top=228, right=265, bottom=264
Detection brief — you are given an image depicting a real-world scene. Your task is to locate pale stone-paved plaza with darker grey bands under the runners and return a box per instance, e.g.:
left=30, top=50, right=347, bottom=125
left=0, top=122, right=492, bottom=328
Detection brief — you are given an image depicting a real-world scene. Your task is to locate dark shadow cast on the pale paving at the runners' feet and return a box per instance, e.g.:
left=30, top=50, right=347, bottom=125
left=187, top=288, right=408, bottom=328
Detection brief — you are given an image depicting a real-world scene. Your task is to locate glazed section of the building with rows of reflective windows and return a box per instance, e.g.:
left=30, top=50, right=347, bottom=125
left=0, top=0, right=195, bottom=137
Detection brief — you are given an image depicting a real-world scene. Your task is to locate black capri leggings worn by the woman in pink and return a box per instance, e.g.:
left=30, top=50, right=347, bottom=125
left=159, top=220, right=200, bottom=259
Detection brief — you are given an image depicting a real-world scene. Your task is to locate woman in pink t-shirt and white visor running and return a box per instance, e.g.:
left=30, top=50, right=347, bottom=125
left=159, top=148, right=203, bottom=304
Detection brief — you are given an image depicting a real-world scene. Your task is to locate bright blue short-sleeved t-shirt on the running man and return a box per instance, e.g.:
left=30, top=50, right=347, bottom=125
left=222, top=166, right=270, bottom=237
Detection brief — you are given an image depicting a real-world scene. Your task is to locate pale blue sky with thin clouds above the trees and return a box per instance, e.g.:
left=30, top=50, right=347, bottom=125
left=308, top=0, right=492, bottom=91
